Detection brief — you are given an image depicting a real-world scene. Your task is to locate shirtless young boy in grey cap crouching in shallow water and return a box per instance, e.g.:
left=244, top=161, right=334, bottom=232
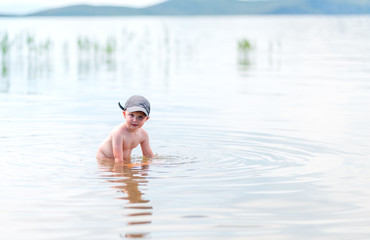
left=96, top=95, right=154, bottom=163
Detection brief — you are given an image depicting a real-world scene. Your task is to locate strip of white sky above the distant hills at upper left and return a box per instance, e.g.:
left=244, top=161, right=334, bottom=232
left=0, top=0, right=166, bottom=14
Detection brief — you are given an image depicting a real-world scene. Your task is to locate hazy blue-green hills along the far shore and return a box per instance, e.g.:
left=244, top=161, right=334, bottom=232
left=6, top=0, right=370, bottom=16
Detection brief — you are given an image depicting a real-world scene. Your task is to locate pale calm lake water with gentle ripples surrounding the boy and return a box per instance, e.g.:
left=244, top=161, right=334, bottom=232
left=0, top=16, right=370, bottom=240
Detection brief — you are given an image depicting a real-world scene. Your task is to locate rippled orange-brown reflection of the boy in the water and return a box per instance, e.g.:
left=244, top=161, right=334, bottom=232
left=99, top=159, right=153, bottom=238
